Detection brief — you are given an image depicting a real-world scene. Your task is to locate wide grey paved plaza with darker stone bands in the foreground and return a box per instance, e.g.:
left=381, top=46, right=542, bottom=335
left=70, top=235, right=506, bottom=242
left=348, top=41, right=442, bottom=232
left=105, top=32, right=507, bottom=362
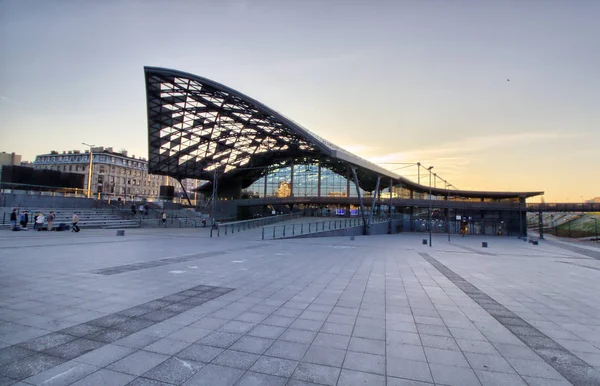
left=0, top=229, right=600, bottom=386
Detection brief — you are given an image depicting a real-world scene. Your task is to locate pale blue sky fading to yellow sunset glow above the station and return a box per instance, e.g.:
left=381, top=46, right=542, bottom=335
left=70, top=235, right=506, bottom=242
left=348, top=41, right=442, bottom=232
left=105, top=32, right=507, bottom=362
left=0, top=0, right=600, bottom=202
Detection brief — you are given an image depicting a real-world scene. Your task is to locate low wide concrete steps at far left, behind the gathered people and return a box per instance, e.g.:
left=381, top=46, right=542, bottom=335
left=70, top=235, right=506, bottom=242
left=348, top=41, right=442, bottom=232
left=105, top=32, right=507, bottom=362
left=0, top=207, right=140, bottom=229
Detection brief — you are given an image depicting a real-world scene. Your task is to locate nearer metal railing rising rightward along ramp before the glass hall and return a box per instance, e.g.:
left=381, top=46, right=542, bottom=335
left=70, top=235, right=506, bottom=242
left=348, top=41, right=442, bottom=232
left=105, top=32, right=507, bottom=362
left=261, top=217, right=390, bottom=240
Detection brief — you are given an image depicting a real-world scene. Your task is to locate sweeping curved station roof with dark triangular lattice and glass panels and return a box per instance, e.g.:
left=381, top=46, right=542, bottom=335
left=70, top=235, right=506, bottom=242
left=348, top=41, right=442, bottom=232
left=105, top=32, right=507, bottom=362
left=144, top=67, right=541, bottom=197
